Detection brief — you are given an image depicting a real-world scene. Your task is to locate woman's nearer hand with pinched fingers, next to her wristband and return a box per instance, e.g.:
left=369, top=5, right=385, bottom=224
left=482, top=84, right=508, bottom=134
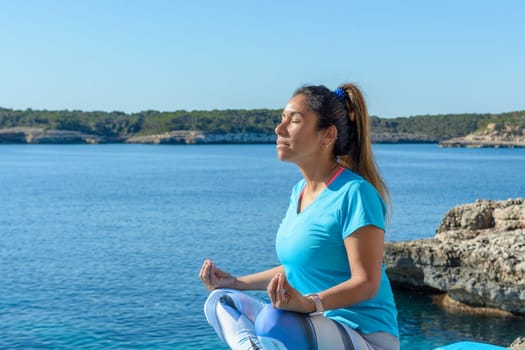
left=266, top=272, right=315, bottom=313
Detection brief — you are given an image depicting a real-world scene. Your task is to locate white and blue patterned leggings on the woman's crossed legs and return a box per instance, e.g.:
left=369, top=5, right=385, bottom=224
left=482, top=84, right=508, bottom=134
left=204, top=289, right=399, bottom=350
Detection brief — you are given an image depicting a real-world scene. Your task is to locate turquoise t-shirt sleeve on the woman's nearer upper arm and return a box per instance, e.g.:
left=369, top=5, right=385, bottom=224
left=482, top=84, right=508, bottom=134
left=340, top=181, right=386, bottom=239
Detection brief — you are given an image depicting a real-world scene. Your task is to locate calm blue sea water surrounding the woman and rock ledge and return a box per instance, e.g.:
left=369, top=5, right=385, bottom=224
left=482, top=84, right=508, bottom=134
left=0, top=145, right=525, bottom=349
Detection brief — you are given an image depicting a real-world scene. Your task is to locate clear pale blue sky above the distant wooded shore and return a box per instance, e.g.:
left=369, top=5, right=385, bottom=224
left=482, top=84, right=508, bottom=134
left=0, top=0, right=525, bottom=117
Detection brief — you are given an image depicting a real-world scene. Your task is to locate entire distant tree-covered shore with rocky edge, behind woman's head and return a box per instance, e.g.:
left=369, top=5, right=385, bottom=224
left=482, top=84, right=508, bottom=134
left=0, top=107, right=525, bottom=147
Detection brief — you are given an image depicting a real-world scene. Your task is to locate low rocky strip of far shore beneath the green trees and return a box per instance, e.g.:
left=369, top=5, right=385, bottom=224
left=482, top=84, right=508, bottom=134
left=4, top=116, right=525, bottom=148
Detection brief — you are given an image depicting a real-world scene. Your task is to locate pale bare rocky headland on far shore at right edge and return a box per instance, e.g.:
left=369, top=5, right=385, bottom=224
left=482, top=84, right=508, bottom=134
left=439, top=123, right=525, bottom=148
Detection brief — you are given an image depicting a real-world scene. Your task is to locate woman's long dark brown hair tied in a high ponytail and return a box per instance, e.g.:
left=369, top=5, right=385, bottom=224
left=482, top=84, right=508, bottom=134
left=294, top=84, right=391, bottom=213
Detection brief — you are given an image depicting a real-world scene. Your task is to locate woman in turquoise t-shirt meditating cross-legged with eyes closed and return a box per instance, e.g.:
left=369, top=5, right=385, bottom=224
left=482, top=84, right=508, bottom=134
left=199, top=84, right=399, bottom=349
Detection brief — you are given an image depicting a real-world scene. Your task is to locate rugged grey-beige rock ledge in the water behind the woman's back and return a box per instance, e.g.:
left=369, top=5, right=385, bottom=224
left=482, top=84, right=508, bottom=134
left=385, top=198, right=525, bottom=316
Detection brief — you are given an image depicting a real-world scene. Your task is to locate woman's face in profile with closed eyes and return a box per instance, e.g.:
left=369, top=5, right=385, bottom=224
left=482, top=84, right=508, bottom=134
left=275, top=95, right=324, bottom=165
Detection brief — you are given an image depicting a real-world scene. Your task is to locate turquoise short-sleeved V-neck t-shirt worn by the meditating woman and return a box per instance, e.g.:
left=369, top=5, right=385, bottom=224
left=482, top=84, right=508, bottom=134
left=276, top=170, right=399, bottom=336
